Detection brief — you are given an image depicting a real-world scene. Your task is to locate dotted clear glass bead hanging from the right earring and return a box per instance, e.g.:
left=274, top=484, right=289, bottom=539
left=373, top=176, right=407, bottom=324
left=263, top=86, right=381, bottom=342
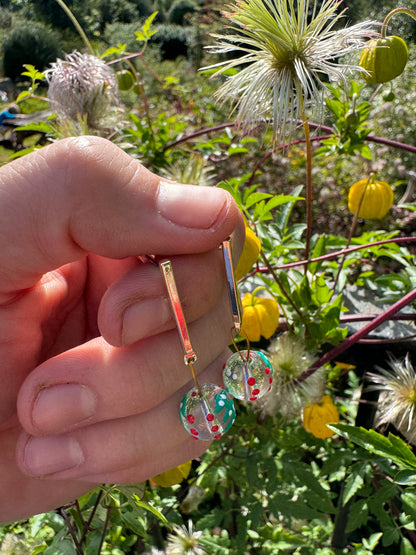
left=223, top=351, right=273, bottom=401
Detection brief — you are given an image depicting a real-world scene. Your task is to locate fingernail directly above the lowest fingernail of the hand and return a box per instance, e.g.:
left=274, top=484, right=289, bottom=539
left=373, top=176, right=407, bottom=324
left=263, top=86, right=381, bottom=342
left=32, top=384, right=97, bottom=434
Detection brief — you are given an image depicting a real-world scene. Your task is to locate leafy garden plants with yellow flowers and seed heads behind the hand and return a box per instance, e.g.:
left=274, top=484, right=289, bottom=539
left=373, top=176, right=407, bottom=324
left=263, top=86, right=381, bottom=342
left=0, top=0, right=416, bottom=555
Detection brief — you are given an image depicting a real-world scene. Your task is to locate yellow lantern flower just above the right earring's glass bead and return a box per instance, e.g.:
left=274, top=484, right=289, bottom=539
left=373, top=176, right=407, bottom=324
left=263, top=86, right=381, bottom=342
left=241, top=293, right=279, bottom=341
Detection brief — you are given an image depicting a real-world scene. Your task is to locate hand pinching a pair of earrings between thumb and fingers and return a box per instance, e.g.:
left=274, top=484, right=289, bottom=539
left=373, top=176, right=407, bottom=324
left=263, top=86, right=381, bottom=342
left=0, top=137, right=244, bottom=522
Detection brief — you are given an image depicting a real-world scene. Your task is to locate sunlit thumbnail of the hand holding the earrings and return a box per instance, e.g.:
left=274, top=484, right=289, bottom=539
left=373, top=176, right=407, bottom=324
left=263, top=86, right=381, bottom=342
left=156, top=181, right=229, bottom=229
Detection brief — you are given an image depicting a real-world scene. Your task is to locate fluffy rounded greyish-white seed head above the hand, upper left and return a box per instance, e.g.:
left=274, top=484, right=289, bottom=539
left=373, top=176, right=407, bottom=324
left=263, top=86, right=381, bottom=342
left=46, top=51, right=118, bottom=129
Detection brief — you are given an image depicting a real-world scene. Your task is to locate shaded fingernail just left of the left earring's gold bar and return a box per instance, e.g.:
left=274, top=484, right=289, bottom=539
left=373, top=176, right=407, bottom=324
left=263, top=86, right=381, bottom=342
left=121, top=297, right=171, bottom=345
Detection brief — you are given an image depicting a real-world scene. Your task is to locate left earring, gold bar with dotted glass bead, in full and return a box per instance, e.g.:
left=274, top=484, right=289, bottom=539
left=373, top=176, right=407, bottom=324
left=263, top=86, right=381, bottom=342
left=159, top=260, right=236, bottom=441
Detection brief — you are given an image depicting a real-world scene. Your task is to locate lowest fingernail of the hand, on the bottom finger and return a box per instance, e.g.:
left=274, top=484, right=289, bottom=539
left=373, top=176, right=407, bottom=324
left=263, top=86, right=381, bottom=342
left=24, top=435, right=84, bottom=476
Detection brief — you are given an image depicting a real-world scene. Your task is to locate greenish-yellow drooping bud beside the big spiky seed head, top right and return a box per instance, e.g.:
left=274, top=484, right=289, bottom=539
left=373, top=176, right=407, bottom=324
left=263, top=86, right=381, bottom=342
left=360, top=36, right=409, bottom=85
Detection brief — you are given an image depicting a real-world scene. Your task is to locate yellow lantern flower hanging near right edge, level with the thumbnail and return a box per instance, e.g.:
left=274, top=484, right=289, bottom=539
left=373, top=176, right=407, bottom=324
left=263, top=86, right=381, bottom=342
left=348, top=178, right=393, bottom=220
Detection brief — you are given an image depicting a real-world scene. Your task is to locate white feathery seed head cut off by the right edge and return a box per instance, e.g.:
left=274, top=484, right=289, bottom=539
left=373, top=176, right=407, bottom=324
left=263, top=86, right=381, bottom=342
left=367, top=355, right=416, bottom=443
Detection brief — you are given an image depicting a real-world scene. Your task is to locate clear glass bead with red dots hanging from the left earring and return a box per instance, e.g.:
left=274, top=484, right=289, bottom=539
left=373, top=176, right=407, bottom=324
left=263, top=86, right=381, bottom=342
left=179, top=383, right=235, bottom=441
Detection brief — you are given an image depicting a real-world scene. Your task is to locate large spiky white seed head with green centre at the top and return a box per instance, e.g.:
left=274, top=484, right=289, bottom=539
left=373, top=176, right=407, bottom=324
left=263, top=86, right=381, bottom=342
left=207, top=0, right=374, bottom=146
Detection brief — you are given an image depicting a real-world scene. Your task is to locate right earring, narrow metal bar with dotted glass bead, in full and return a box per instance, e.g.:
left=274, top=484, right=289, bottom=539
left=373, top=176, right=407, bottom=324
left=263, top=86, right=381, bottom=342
left=222, top=241, right=273, bottom=401
